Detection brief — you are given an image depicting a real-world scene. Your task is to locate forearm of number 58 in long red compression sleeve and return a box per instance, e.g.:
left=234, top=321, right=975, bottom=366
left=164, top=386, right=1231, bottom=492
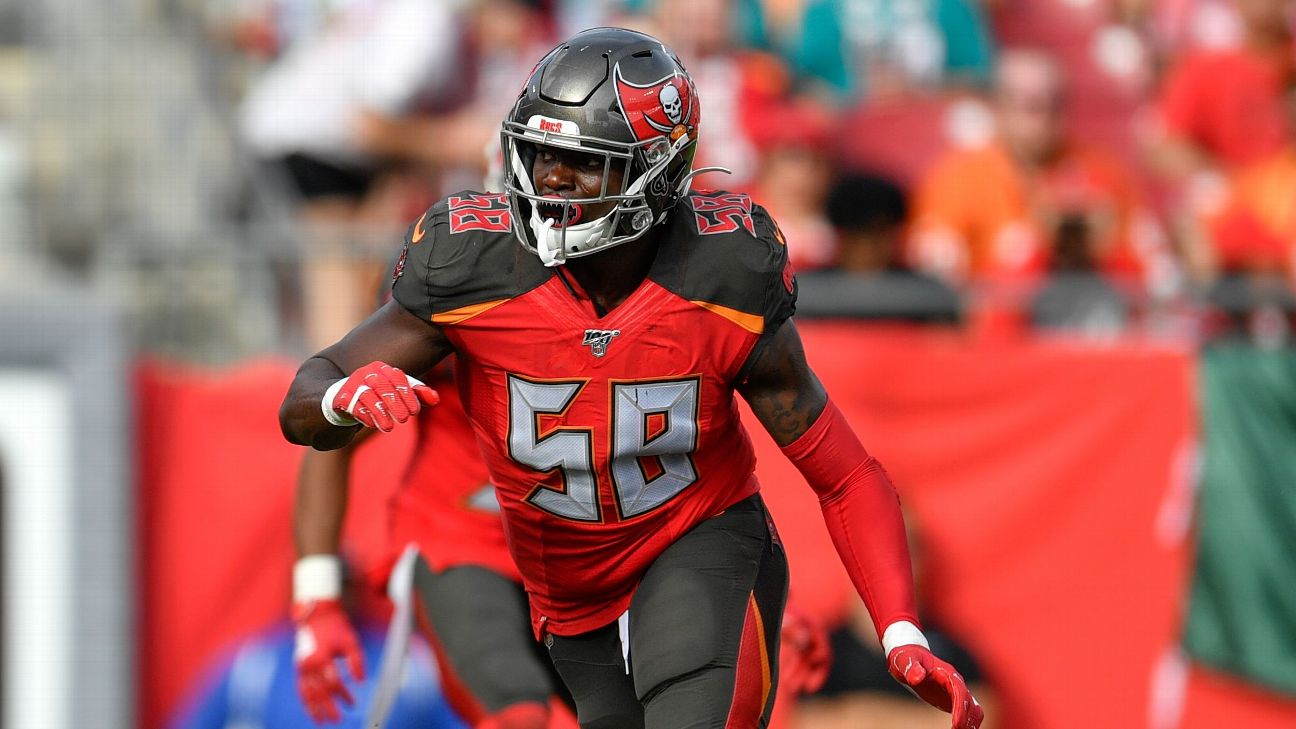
left=783, top=402, right=919, bottom=637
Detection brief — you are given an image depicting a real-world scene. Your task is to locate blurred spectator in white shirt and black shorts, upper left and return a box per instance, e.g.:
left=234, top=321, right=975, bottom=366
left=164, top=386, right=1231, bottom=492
left=241, top=0, right=461, bottom=348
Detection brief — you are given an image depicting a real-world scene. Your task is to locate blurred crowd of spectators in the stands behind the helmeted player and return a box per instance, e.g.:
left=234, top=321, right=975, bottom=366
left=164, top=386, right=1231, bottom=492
left=207, top=0, right=1296, bottom=345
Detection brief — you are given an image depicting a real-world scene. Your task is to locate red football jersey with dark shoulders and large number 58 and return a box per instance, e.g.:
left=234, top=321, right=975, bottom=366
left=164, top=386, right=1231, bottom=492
left=393, top=188, right=796, bottom=634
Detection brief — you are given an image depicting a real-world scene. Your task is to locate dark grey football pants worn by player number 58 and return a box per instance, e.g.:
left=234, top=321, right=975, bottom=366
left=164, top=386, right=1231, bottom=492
left=546, top=496, right=788, bottom=729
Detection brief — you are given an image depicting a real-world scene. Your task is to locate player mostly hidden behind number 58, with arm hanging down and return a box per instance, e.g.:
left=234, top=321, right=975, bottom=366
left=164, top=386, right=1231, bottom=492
left=293, top=358, right=574, bottom=729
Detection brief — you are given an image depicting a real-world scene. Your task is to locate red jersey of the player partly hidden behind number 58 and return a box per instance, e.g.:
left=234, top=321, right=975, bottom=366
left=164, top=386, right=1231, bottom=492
left=388, top=368, right=521, bottom=581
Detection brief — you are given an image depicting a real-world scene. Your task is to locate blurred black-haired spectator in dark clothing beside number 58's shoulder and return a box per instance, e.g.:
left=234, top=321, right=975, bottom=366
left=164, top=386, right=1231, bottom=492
left=788, top=174, right=962, bottom=323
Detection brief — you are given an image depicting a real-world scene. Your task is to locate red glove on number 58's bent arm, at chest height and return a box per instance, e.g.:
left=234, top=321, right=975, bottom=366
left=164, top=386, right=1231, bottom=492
left=323, top=362, right=441, bottom=433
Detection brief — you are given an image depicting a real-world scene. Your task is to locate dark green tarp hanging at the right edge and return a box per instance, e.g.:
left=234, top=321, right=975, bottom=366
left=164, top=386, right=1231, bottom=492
left=1185, top=346, right=1296, bottom=695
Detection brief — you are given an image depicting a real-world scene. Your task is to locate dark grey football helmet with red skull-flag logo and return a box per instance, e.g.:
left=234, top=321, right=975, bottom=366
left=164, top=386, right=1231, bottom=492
left=500, top=27, right=701, bottom=266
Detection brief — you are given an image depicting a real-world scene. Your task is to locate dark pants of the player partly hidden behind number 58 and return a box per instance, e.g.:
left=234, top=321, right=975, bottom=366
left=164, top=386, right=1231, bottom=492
left=413, top=559, right=565, bottom=725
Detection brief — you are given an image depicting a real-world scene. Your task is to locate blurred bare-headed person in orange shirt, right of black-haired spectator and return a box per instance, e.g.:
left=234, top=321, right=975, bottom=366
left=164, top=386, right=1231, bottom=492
left=908, top=49, right=1151, bottom=284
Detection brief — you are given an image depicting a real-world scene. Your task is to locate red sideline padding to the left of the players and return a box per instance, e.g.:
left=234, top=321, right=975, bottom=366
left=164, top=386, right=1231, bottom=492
left=135, top=361, right=413, bottom=729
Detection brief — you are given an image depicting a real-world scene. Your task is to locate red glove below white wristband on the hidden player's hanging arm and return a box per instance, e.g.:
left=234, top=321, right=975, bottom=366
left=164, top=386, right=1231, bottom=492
left=293, top=599, right=364, bottom=724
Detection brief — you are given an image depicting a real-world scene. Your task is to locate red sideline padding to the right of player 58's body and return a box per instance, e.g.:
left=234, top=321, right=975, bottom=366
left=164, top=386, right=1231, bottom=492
left=756, top=324, right=1194, bottom=729
